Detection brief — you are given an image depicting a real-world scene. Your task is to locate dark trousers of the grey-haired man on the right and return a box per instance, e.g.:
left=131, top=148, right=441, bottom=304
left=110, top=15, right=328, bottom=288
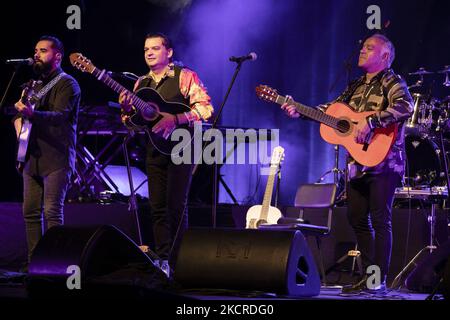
left=348, top=173, right=400, bottom=281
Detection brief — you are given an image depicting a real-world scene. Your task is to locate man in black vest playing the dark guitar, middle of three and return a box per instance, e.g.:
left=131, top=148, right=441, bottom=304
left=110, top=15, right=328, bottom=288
left=119, top=33, right=213, bottom=275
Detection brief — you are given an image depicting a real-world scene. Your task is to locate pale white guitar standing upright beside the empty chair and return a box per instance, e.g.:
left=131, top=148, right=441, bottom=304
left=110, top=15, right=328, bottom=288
left=246, top=146, right=284, bottom=229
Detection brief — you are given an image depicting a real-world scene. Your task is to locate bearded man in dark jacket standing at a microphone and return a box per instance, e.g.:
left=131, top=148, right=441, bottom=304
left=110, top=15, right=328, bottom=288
left=14, top=36, right=81, bottom=268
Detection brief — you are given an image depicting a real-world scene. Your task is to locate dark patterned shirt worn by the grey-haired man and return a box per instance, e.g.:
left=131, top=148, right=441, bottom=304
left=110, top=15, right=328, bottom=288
left=319, top=69, right=414, bottom=179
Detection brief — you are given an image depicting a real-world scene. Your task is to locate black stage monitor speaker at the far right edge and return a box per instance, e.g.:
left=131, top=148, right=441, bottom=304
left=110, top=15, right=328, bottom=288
left=405, top=240, right=450, bottom=293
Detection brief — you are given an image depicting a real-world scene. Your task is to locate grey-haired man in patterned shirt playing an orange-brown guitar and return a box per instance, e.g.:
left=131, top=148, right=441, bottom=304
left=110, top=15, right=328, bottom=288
left=282, top=34, right=413, bottom=293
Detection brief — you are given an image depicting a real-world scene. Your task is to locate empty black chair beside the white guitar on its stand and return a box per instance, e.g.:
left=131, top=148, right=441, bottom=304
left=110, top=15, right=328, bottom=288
left=260, top=183, right=337, bottom=285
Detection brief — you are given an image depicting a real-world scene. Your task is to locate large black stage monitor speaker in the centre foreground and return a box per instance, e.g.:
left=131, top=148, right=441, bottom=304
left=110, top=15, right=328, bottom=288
left=175, top=229, right=320, bottom=297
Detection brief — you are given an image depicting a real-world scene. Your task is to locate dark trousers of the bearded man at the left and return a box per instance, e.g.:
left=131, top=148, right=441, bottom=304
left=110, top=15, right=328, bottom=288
left=23, top=169, right=71, bottom=262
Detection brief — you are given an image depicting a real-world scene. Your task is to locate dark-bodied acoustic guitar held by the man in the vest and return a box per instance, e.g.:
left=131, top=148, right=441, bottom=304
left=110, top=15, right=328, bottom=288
left=70, top=53, right=192, bottom=155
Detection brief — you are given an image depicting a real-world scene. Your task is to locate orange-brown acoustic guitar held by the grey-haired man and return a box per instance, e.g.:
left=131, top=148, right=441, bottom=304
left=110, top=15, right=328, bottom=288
left=256, top=85, right=398, bottom=167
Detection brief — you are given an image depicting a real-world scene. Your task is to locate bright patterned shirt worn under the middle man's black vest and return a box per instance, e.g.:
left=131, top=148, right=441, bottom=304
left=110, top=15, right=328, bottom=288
left=134, top=63, right=214, bottom=125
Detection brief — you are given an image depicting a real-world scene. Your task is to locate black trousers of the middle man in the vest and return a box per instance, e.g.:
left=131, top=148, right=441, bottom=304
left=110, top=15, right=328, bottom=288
left=147, top=154, right=193, bottom=267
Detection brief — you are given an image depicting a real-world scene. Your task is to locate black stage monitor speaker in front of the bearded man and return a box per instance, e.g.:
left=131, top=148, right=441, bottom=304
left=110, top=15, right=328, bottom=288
left=27, top=225, right=168, bottom=296
